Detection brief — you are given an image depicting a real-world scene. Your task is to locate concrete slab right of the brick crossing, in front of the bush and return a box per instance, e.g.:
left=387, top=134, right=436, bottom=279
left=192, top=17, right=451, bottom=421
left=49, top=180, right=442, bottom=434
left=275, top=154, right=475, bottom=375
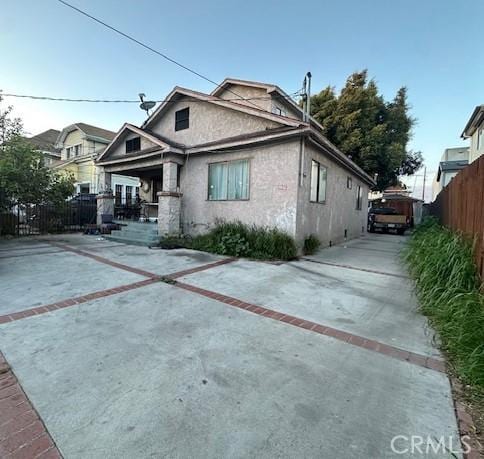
left=180, top=258, right=440, bottom=357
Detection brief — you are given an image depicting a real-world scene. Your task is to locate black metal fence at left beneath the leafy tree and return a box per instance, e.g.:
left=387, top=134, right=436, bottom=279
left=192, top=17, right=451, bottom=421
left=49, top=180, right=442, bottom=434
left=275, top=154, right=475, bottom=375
left=0, top=198, right=97, bottom=237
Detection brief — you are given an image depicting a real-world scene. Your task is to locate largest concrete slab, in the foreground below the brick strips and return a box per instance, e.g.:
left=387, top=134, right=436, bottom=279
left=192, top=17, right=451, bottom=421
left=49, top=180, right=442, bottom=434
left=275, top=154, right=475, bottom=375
left=0, top=284, right=459, bottom=459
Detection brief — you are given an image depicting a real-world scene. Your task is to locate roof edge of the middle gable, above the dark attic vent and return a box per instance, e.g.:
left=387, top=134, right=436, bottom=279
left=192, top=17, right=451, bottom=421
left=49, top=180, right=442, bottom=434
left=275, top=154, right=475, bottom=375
left=141, top=86, right=302, bottom=129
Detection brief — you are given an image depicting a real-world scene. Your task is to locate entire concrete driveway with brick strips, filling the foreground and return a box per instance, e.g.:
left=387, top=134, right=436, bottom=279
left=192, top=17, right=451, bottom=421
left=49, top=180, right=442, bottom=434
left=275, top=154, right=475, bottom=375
left=0, top=235, right=461, bottom=459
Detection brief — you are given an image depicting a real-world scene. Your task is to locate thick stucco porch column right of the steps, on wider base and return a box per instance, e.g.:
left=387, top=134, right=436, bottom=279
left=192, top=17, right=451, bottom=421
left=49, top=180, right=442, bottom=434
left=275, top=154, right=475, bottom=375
left=158, top=162, right=183, bottom=236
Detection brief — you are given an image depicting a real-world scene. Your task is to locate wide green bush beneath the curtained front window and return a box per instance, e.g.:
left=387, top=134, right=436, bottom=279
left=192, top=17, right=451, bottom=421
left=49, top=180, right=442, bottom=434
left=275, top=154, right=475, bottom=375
left=191, top=221, right=297, bottom=260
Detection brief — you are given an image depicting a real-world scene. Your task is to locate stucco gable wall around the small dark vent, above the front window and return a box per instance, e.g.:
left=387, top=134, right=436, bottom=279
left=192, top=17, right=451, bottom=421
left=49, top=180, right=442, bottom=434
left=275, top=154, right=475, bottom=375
left=151, top=97, right=280, bottom=146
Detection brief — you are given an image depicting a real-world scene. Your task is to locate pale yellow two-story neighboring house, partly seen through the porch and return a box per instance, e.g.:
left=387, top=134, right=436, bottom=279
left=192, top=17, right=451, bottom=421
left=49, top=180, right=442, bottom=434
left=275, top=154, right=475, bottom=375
left=54, top=123, right=139, bottom=201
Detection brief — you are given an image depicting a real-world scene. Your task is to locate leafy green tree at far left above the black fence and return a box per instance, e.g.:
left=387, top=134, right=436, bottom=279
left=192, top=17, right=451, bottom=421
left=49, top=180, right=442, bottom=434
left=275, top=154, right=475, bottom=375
left=0, top=136, right=74, bottom=209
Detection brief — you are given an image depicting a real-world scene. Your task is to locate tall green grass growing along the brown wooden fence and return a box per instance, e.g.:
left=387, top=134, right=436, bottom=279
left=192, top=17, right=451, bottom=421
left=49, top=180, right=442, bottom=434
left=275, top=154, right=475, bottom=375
left=404, top=218, right=484, bottom=388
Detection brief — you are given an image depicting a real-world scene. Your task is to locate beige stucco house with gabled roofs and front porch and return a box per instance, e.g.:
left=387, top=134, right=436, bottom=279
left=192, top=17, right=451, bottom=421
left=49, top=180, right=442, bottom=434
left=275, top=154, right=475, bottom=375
left=96, top=79, right=374, bottom=245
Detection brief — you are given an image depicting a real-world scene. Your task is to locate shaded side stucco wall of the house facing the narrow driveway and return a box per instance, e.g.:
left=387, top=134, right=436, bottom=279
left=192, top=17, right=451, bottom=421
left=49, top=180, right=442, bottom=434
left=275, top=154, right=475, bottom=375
left=297, top=144, right=369, bottom=246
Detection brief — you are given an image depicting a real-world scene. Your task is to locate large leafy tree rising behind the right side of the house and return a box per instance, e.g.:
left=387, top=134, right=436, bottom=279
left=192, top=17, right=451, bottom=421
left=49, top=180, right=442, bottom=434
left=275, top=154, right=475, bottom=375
left=311, top=70, right=422, bottom=190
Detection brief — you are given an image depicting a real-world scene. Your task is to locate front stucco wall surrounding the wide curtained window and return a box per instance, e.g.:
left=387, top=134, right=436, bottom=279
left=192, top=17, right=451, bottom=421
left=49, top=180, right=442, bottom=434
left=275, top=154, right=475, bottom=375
left=180, top=141, right=299, bottom=236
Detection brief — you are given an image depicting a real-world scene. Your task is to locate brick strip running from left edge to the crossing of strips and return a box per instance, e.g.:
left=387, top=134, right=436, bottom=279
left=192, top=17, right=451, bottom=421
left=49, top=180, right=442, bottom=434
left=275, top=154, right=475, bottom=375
left=0, top=276, right=160, bottom=324
